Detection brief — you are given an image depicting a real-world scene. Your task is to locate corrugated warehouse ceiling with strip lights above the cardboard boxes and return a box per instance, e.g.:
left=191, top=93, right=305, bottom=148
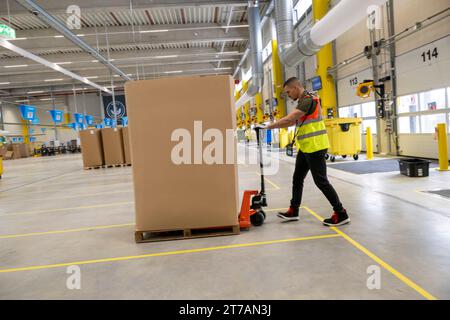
left=0, top=0, right=268, bottom=96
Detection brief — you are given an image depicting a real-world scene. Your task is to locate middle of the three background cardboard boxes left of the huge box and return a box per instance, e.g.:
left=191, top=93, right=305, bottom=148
left=101, top=128, right=125, bottom=166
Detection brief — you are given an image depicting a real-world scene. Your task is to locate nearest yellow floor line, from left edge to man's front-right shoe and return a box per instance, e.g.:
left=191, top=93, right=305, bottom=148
left=0, top=234, right=340, bottom=273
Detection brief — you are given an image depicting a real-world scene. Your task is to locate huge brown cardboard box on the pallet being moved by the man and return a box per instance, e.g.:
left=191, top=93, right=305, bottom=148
left=125, top=76, right=238, bottom=231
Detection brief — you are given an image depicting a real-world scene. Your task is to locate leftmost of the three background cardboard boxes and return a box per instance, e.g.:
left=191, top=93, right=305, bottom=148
left=80, top=129, right=105, bottom=168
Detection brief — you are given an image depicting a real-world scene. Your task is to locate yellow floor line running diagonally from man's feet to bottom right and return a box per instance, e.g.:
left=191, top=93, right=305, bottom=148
left=304, top=207, right=437, bottom=300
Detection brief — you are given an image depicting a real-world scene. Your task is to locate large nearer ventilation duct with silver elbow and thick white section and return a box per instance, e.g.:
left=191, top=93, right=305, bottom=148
left=274, top=0, right=386, bottom=67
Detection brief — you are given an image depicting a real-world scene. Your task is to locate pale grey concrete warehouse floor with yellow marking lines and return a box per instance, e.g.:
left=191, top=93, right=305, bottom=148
left=0, top=145, right=450, bottom=299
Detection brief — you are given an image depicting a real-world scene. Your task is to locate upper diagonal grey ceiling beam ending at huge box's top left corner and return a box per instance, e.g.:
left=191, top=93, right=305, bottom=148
left=16, top=0, right=132, bottom=80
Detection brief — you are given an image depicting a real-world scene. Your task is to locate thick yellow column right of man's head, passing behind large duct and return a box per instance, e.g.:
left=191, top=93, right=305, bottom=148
left=313, top=0, right=337, bottom=117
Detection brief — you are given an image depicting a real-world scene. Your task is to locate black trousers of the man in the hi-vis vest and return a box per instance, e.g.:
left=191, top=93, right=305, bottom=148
left=291, top=149, right=343, bottom=212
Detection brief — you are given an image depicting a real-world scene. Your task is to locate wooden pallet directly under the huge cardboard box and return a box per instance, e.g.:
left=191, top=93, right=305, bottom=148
left=134, top=226, right=240, bottom=243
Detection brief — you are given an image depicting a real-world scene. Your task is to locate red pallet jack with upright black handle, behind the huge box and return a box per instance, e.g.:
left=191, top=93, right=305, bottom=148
left=239, top=128, right=267, bottom=230
